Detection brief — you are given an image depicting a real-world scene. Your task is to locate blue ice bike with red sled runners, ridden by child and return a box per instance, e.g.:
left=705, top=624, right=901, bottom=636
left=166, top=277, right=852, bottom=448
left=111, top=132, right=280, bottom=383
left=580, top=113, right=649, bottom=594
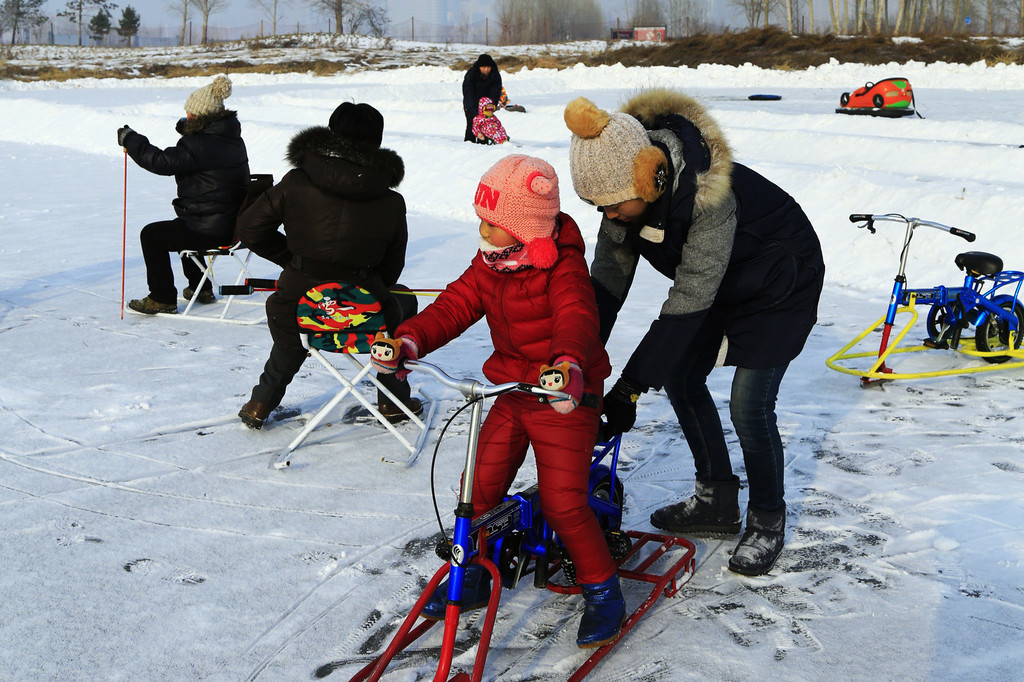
left=351, top=360, right=696, bottom=682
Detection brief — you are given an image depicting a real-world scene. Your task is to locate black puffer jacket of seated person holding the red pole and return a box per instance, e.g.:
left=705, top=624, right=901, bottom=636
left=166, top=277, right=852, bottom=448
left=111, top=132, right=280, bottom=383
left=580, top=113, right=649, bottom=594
left=124, top=111, right=249, bottom=237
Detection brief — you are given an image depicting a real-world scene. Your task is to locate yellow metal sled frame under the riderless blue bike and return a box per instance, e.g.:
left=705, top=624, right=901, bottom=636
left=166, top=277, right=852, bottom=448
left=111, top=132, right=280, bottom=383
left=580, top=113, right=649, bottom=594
left=825, top=294, right=1024, bottom=384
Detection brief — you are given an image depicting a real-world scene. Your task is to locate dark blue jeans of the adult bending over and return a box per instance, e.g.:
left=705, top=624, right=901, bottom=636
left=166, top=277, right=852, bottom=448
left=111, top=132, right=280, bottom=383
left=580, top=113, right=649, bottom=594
left=665, top=323, right=788, bottom=511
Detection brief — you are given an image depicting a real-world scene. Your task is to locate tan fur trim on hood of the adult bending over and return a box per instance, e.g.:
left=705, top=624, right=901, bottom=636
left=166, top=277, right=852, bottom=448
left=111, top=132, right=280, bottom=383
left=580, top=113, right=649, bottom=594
left=620, top=88, right=732, bottom=209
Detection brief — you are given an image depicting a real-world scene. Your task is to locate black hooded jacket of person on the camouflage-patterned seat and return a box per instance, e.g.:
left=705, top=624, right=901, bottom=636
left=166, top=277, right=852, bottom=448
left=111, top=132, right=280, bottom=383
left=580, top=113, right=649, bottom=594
left=239, top=127, right=409, bottom=329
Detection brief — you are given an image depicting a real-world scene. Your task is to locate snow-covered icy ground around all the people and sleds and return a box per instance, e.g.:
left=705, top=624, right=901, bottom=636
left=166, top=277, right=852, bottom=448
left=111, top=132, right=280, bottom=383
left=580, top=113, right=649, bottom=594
left=0, top=49, right=1024, bottom=681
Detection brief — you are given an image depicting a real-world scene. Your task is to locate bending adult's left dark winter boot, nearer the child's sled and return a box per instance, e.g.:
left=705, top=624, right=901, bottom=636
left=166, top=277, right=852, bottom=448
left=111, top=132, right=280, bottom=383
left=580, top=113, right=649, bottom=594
left=650, top=476, right=739, bottom=532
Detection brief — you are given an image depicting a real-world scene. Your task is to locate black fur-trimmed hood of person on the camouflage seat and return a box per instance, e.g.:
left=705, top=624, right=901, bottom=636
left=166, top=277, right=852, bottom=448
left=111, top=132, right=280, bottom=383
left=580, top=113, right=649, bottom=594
left=286, top=126, right=406, bottom=198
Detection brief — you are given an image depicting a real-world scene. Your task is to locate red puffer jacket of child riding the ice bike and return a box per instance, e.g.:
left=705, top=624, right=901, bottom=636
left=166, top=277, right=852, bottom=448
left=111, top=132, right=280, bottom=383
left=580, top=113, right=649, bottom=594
left=395, top=213, right=611, bottom=393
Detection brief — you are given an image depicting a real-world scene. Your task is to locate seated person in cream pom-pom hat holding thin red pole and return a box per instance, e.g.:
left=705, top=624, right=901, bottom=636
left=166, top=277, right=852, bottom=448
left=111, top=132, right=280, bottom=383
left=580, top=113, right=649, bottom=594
left=118, top=76, right=249, bottom=314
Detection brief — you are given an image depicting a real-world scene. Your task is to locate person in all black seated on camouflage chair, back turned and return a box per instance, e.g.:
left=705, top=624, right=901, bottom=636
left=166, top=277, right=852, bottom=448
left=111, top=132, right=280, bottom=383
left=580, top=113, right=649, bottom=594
left=239, top=102, right=423, bottom=429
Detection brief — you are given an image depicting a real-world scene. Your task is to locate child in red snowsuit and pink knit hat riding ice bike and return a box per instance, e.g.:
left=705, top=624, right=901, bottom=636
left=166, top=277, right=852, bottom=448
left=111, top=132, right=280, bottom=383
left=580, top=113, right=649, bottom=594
left=372, top=155, right=626, bottom=648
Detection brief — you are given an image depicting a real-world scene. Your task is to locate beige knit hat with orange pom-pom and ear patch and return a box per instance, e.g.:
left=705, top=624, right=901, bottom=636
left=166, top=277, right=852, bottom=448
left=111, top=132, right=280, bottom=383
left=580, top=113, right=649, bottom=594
left=564, top=97, right=668, bottom=206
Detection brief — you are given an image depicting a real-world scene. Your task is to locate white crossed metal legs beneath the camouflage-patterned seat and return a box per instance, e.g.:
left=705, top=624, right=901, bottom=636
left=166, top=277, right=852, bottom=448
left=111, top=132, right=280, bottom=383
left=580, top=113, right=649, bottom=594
left=273, top=334, right=437, bottom=469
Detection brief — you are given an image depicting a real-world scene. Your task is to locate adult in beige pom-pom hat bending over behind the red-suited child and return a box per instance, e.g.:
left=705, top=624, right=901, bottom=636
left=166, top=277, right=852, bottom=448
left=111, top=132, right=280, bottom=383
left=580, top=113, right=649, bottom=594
left=564, top=90, right=824, bottom=576
